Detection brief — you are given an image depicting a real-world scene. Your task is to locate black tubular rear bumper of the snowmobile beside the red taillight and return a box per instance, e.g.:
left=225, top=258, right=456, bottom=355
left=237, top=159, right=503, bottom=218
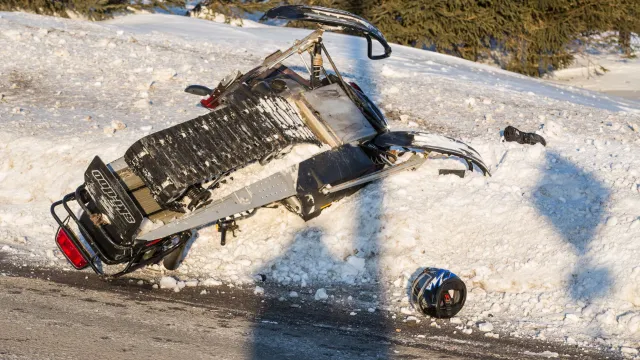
left=51, top=184, right=189, bottom=278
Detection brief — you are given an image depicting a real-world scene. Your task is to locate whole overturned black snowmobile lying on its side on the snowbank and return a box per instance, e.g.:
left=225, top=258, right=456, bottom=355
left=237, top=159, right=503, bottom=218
left=51, top=6, right=488, bottom=276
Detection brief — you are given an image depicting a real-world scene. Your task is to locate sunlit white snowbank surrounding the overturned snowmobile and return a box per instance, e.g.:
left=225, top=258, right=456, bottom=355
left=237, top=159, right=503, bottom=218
left=0, top=13, right=640, bottom=356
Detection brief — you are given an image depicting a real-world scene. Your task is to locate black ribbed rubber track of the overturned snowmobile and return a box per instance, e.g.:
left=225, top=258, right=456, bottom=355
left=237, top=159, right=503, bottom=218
left=125, top=96, right=319, bottom=208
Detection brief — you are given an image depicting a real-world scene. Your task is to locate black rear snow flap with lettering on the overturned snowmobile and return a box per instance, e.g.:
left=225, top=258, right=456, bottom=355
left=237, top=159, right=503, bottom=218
left=84, top=156, right=143, bottom=244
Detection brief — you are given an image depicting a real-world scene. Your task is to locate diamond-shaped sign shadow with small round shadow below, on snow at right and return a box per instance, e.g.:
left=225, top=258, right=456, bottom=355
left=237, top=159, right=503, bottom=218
left=533, top=152, right=612, bottom=301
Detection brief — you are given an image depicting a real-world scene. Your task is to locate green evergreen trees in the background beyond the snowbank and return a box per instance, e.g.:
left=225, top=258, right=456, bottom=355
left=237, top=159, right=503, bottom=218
left=0, top=0, right=640, bottom=76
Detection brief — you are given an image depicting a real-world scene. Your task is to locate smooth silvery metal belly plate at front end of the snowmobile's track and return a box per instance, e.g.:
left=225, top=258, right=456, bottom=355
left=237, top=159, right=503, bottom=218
left=303, top=84, right=378, bottom=145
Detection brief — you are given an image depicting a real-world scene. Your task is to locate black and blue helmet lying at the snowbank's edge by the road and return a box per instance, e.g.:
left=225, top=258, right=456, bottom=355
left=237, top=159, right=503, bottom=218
left=410, top=268, right=467, bottom=318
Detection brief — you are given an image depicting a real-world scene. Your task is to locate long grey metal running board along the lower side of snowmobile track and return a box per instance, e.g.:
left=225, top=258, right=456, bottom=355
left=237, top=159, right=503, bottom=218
left=138, top=170, right=297, bottom=241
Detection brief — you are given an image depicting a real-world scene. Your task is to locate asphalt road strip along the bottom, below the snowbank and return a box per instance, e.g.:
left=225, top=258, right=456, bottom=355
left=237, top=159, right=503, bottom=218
left=0, top=260, right=614, bottom=360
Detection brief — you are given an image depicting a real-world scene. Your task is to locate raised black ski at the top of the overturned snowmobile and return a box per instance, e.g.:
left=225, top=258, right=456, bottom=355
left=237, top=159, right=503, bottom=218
left=262, top=5, right=391, bottom=60
